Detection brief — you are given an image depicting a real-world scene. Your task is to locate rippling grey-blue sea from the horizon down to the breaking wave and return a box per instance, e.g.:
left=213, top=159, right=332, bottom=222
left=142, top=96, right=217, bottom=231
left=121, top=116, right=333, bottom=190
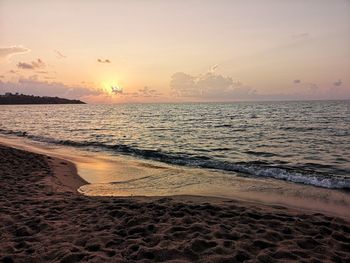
left=0, top=101, right=350, bottom=189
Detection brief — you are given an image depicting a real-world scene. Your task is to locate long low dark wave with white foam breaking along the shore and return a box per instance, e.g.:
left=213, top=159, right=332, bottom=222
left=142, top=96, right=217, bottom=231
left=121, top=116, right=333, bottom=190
left=0, top=129, right=350, bottom=189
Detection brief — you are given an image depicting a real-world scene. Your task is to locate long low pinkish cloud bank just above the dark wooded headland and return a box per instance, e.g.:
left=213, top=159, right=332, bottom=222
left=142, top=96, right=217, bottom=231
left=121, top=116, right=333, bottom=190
left=0, top=78, right=103, bottom=99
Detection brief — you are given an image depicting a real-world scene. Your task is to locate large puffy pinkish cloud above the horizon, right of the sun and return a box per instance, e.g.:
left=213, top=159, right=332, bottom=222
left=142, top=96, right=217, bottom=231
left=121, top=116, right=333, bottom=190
left=170, top=70, right=252, bottom=100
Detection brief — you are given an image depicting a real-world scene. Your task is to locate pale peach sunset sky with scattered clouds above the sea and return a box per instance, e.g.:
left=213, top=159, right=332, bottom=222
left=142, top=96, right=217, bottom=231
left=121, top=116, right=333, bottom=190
left=0, top=0, right=350, bottom=103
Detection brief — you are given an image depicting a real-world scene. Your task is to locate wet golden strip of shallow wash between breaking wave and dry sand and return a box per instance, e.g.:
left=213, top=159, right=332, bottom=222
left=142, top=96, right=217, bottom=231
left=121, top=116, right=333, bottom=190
left=0, top=135, right=350, bottom=218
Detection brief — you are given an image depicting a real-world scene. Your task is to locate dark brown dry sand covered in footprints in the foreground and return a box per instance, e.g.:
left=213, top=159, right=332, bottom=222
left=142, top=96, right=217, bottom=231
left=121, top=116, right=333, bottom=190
left=0, top=145, right=350, bottom=262
